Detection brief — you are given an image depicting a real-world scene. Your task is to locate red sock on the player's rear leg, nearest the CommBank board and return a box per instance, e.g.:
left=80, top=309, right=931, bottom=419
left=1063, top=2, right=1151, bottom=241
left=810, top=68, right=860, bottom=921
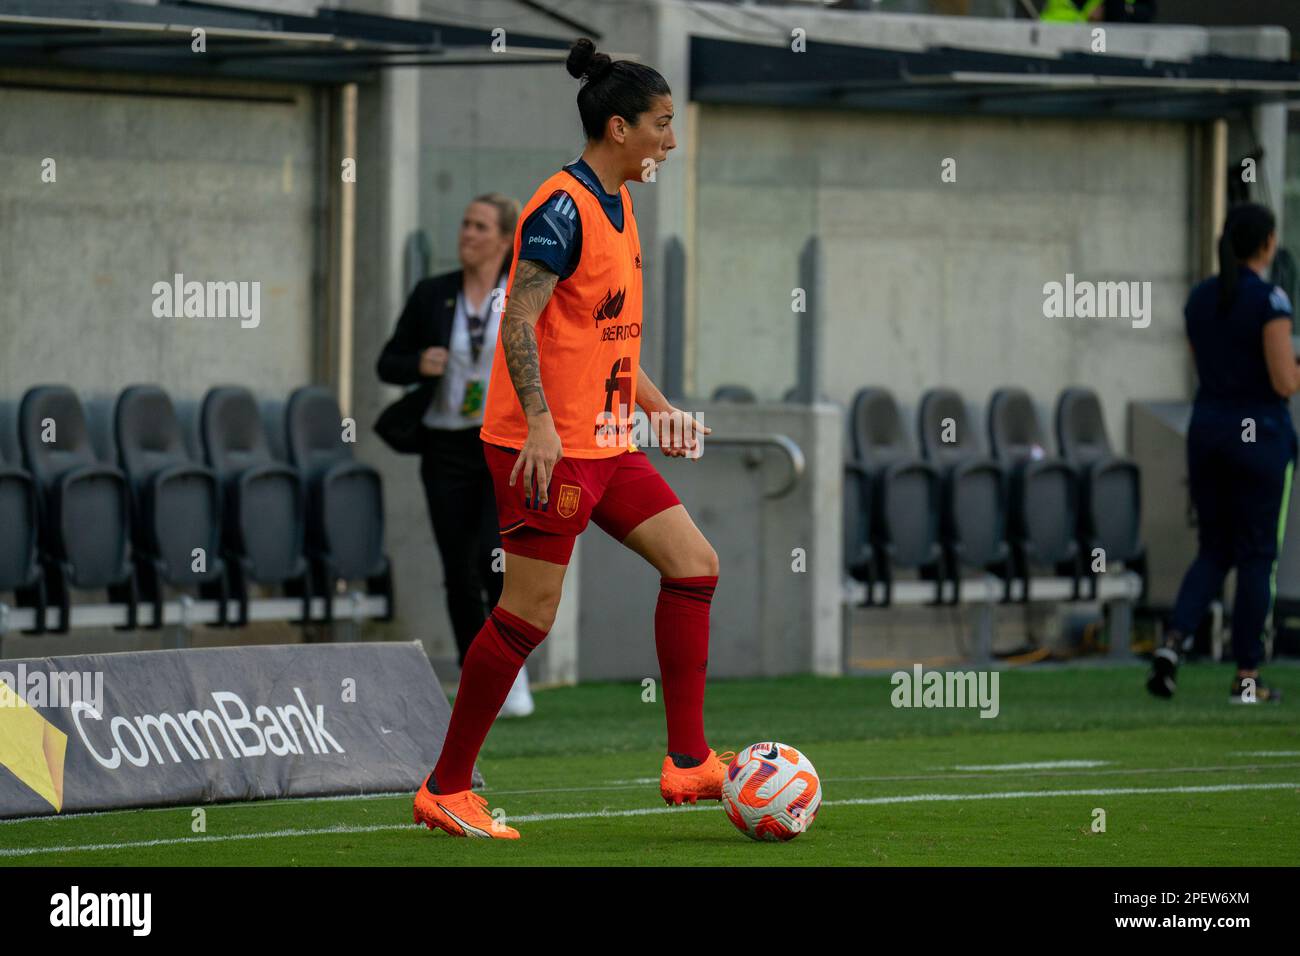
left=433, top=606, right=546, bottom=793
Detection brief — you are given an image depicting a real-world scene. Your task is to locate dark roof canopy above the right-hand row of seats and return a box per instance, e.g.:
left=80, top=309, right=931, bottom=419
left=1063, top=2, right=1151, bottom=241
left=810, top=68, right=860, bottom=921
left=690, top=36, right=1300, bottom=121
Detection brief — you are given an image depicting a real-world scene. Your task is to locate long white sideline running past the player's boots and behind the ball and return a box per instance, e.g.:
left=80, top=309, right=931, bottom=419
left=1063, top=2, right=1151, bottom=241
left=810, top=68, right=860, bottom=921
left=0, top=783, right=1300, bottom=857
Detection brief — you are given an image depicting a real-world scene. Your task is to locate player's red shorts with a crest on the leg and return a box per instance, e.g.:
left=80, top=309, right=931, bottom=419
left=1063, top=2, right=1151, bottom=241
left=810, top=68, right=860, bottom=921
left=484, top=442, right=681, bottom=564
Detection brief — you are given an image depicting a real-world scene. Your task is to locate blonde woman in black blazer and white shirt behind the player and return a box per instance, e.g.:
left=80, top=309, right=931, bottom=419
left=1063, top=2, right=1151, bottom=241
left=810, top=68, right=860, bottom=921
left=378, top=193, right=533, bottom=715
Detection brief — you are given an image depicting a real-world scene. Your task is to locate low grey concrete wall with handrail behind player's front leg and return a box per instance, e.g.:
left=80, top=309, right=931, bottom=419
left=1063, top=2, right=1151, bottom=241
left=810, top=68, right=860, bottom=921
left=577, top=403, right=844, bottom=680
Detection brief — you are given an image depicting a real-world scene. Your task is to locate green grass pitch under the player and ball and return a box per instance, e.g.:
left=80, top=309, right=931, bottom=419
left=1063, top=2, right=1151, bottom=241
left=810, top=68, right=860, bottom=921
left=0, top=663, right=1300, bottom=866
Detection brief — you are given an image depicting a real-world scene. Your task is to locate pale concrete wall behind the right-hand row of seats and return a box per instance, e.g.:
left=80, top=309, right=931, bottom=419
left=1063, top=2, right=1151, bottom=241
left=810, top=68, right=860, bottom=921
left=694, top=107, right=1192, bottom=444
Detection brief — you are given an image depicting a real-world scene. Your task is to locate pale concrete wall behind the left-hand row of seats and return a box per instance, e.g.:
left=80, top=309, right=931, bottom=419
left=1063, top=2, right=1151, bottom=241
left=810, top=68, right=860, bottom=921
left=0, top=72, right=320, bottom=421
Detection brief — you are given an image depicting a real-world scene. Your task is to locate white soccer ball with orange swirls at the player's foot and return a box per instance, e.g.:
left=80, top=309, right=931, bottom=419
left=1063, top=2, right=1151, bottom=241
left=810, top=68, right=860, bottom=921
left=723, top=743, right=822, bottom=843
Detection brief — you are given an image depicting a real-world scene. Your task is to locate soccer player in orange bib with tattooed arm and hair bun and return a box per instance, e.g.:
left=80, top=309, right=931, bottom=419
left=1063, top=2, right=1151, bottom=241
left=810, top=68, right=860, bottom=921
left=415, top=38, right=728, bottom=839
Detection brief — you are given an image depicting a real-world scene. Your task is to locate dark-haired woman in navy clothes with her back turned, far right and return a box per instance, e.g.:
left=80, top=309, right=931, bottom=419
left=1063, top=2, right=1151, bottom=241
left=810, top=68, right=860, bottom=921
left=1147, top=203, right=1300, bottom=704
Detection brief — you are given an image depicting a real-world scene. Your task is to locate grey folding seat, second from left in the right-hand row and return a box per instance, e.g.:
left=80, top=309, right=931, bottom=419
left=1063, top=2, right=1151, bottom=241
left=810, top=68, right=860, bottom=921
left=917, top=389, right=1014, bottom=604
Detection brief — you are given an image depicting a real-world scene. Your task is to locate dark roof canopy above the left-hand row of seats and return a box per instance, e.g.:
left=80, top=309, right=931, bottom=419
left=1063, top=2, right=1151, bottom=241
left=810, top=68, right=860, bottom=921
left=0, top=0, right=585, bottom=83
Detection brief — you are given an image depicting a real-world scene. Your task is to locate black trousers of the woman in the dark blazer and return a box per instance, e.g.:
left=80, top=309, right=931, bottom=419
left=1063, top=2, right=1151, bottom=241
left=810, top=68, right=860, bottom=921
left=420, top=428, right=504, bottom=665
